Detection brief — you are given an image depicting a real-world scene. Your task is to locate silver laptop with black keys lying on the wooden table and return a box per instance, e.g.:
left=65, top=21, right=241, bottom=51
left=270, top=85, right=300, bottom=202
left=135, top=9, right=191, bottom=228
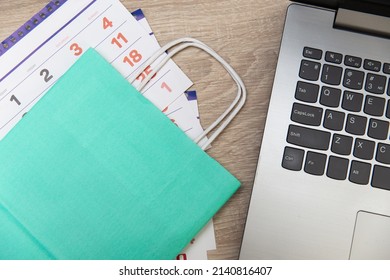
left=240, top=0, right=390, bottom=259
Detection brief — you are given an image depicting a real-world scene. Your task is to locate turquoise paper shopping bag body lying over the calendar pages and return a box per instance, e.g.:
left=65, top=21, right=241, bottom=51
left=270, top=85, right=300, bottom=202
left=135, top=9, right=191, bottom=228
left=0, top=49, right=240, bottom=259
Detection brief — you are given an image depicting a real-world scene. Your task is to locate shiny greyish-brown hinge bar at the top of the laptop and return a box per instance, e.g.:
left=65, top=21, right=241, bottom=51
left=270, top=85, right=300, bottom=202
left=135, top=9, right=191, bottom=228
left=334, top=8, right=390, bottom=38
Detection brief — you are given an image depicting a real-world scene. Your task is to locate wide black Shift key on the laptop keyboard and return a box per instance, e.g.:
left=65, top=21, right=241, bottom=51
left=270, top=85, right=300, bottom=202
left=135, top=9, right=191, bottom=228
left=287, top=125, right=330, bottom=151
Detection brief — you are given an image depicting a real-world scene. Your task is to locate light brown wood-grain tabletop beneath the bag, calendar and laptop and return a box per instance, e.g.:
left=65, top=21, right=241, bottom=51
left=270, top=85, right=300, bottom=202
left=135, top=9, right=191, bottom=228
left=0, top=0, right=289, bottom=259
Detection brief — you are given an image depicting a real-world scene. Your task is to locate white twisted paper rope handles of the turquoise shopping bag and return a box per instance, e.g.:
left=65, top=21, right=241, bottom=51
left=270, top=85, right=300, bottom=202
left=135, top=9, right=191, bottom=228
left=129, top=38, right=247, bottom=150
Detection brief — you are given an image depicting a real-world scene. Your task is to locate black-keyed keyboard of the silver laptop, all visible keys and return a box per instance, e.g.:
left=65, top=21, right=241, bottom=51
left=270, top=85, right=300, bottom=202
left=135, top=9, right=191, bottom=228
left=282, top=47, right=390, bottom=190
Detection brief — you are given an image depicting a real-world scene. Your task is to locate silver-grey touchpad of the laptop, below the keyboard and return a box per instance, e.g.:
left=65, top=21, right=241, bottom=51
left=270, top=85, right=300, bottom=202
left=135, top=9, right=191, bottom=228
left=350, top=211, right=390, bottom=260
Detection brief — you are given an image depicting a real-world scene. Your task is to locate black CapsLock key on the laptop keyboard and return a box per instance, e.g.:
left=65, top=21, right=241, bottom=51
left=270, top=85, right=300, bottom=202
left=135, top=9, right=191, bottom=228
left=291, top=103, right=323, bottom=126
